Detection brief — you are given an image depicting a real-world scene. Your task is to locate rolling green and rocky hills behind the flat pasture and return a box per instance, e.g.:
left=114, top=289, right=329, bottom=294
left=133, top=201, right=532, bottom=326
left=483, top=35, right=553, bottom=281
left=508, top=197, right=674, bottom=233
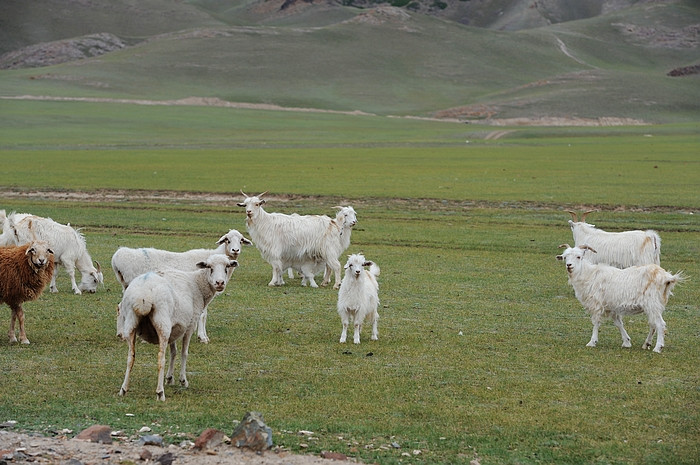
left=0, top=0, right=700, bottom=124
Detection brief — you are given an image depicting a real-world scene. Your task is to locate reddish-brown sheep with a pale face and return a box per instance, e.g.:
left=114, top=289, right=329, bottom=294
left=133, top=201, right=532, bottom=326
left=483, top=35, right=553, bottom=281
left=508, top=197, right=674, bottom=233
left=0, top=240, right=54, bottom=344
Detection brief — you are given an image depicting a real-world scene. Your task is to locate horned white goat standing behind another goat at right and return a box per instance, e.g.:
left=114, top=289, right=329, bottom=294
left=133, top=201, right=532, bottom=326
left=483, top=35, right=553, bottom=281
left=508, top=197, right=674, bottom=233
left=569, top=210, right=661, bottom=268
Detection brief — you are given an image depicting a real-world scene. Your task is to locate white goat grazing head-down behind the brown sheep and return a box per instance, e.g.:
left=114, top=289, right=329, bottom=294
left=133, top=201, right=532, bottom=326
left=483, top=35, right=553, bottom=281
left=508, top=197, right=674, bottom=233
left=3, top=213, right=104, bottom=294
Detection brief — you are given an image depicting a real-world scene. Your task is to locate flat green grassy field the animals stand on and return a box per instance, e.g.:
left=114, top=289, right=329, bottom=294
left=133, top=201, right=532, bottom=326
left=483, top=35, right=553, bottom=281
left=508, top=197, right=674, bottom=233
left=0, top=101, right=700, bottom=464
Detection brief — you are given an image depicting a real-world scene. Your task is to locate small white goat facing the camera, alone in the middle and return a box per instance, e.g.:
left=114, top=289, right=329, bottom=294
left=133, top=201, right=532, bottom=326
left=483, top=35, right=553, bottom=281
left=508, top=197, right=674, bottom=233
left=338, top=254, right=380, bottom=344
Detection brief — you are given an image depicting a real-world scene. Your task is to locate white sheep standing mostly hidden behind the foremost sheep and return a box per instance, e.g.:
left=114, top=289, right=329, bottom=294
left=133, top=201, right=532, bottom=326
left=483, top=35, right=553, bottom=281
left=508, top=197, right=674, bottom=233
left=112, top=229, right=253, bottom=344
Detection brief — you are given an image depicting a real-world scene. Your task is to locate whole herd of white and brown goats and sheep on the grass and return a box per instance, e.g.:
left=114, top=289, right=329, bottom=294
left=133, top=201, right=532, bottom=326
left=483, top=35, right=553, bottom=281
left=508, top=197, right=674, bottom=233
left=0, top=196, right=685, bottom=400
